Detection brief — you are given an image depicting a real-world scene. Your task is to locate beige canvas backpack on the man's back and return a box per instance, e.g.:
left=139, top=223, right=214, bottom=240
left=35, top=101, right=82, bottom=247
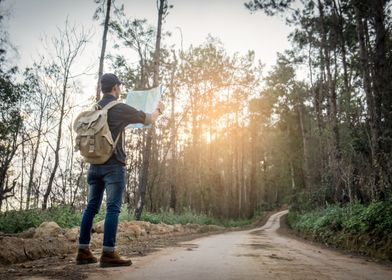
left=73, top=101, right=121, bottom=164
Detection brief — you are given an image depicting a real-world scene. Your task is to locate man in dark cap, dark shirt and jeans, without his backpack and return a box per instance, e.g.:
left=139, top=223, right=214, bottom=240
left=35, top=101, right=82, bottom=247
left=76, top=73, right=164, bottom=267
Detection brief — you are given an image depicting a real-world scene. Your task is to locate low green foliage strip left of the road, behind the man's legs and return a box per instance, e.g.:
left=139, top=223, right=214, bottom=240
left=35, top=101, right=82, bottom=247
left=0, top=205, right=263, bottom=233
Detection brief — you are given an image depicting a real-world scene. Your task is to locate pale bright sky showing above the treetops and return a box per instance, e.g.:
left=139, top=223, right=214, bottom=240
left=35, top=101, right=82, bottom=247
left=2, top=0, right=290, bottom=99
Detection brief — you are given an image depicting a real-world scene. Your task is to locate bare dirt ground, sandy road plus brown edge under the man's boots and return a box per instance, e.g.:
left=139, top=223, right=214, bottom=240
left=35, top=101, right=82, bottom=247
left=0, top=211, right=392, bottom=280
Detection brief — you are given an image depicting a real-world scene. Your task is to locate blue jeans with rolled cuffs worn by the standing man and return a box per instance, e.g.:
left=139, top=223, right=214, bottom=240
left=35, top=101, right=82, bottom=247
left=79, top=164, right=125, bottom=251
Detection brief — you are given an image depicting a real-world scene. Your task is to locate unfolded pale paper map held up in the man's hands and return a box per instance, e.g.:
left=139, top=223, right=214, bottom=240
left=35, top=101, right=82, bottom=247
left=125, top=86, right=162, bottom=128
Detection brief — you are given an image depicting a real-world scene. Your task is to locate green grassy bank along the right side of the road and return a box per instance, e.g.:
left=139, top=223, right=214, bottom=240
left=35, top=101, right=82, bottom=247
left=287, top=198, right=392, bottom=261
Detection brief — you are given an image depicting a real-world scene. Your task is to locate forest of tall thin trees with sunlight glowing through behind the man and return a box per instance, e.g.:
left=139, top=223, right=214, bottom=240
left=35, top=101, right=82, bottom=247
left=0, top=0, right=392, bottom=238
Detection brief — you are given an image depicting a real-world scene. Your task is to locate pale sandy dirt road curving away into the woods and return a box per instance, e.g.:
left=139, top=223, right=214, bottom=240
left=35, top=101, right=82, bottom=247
left=90, top=211, right=392, bottom=280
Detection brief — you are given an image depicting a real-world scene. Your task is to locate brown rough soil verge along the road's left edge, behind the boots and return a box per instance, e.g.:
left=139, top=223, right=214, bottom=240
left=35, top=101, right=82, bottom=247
left=0, top=212, right=272, bottom=280
